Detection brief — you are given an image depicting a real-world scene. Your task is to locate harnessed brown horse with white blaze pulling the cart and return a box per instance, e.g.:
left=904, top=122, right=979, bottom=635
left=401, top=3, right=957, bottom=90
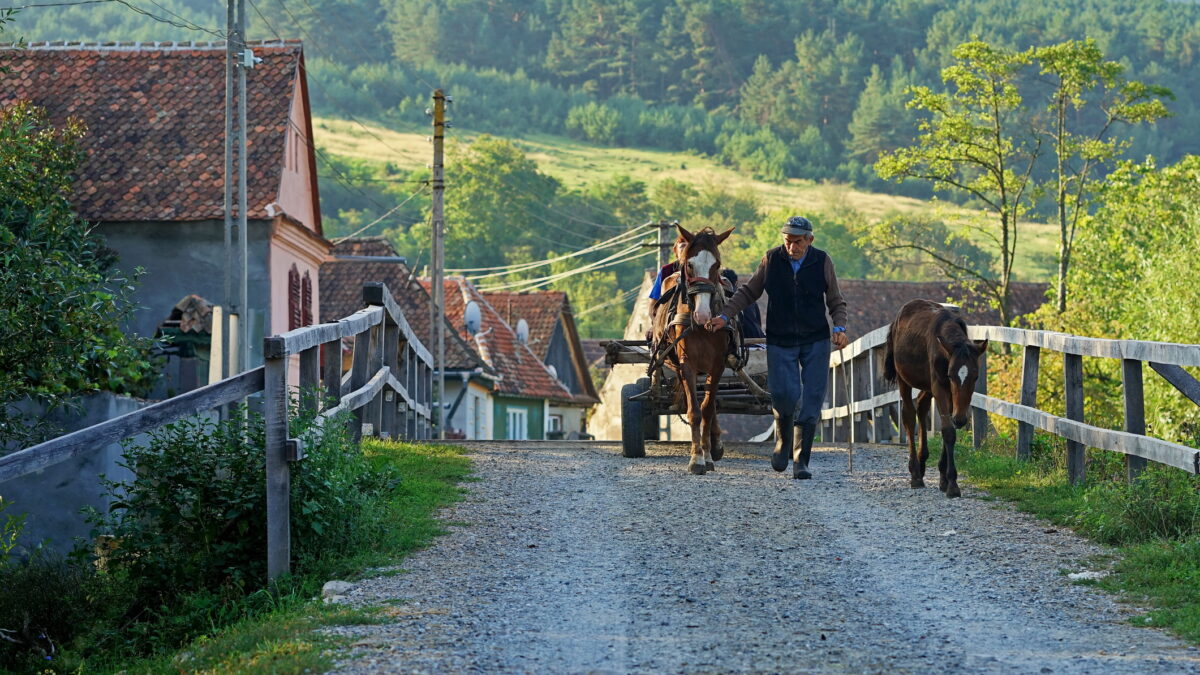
left=654, top=225, right=733, bottom=476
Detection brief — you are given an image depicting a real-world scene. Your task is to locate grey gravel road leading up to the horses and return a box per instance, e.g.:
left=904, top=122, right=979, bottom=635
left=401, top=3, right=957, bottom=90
left=331, top=442, right=1200, bottom=674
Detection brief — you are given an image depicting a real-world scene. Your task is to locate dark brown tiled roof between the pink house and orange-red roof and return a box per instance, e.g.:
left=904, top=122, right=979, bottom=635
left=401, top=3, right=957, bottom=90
left=320, top=239, right=494, bottom=375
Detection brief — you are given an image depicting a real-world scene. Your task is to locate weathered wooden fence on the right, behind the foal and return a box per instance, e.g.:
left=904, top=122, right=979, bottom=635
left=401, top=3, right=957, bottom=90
left=821, top=325, right=1200, bottom=484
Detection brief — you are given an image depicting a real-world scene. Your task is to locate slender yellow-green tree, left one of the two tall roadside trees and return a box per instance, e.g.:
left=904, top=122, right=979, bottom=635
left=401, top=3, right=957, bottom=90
left=875, top=41, right=1042, bottom=325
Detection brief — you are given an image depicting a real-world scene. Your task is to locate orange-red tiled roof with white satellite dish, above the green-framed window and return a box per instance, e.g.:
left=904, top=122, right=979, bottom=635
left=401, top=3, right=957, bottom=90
left=421, top=277, right=574, bottom=402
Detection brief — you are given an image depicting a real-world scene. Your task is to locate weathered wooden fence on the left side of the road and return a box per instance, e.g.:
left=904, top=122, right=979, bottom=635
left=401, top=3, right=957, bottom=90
left=0, top=282, right=433, bottom=579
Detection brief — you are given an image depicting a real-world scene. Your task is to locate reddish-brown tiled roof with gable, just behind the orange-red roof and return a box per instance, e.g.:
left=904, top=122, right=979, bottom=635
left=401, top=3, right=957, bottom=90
left=484, top=291, right=600, bottom=404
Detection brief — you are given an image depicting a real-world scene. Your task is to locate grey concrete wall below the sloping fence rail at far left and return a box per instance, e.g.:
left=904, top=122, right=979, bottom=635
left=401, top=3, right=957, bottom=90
left=0, top=393, right=145, bottom=554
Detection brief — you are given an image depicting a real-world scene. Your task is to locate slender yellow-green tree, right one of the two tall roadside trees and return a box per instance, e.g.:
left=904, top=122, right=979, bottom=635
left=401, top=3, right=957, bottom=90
left=1034, top=40, right=1174, bottom=312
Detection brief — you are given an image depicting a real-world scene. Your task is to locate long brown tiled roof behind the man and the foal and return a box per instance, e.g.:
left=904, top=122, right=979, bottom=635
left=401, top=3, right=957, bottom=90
left=830, top=279, right=1046, bottom=338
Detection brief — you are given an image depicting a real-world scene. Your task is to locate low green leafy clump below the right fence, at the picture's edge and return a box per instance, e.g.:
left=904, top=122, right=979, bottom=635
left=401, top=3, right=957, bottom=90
left=1079, top=467, right=1200, bottom=544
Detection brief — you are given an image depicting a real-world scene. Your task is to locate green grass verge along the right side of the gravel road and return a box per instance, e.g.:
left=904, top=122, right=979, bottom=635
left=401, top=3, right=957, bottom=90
left=930, top=437, right=1200, bottom=644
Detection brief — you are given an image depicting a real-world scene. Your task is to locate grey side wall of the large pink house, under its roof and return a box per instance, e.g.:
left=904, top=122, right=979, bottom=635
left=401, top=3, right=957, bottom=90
left=97, top=220, right=270, bottom=366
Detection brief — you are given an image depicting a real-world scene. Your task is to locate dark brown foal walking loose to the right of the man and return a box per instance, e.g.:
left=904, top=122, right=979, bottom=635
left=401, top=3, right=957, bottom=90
left=883, top=300, right=988, bottom=497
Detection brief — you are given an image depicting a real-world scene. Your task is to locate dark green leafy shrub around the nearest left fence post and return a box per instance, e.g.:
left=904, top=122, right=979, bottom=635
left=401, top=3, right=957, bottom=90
left=92, top=398, right=397, bottom=607
